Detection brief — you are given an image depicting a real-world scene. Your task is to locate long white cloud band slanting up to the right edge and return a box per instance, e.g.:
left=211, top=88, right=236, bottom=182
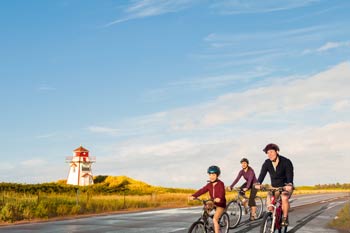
left=91, top=63, right=350, bottom=133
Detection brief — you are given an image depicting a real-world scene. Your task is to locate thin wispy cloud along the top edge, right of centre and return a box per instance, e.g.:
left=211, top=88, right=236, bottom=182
left=211, top=0, right=319, bottom=14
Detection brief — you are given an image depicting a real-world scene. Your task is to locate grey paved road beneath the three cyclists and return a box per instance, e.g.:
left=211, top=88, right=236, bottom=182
left=0, top=193, right=350, bottom=233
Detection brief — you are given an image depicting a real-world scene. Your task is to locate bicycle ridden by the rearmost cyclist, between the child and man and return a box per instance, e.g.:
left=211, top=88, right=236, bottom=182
left=226, top=188, right=264, bottom=229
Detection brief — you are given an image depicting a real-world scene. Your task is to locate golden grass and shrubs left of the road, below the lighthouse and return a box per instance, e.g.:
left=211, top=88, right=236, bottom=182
left=0, top=176, right=193, bottom=222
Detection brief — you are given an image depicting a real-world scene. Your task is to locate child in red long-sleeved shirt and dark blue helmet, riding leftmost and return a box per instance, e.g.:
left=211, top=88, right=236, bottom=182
left=190, top=165, right=226, bottom=233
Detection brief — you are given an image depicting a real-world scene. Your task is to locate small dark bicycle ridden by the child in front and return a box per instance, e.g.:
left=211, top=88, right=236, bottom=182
left=188, top=198, right=230, bottom=233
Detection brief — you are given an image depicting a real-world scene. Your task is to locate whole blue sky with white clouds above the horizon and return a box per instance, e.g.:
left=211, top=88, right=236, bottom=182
left=0, top=0, right=350, bottom=188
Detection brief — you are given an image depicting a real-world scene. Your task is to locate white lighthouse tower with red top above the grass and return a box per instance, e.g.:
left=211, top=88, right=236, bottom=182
left=66, top=146, right=96, bottom=186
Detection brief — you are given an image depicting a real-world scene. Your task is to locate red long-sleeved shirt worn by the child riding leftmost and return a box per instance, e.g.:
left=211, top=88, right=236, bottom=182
left=192, top=180, right=226, bottom=208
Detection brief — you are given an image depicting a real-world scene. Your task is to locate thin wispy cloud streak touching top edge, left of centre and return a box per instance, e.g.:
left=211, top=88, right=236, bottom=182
left=105, top=0, right=198, bottom=27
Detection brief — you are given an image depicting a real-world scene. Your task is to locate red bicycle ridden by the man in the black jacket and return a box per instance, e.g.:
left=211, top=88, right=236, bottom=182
left=260, top=187, right=288, bottom=233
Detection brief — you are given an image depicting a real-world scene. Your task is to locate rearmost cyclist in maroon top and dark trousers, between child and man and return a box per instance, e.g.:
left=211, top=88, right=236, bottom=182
left=228, top=158, right=258, bottom=221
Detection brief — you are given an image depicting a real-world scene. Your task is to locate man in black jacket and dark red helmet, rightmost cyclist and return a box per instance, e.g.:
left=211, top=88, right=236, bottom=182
left=256, top=143, right=294, bottom=226
